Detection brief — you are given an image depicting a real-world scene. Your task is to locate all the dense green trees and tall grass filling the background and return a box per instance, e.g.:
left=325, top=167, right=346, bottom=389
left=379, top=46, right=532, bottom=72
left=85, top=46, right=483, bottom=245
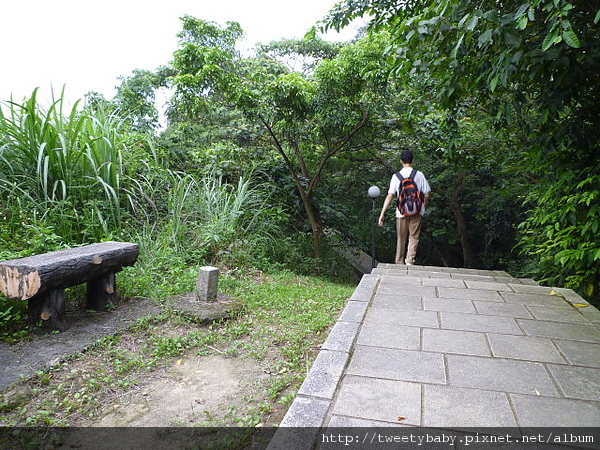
left=0, top=0, right=600, bottom=423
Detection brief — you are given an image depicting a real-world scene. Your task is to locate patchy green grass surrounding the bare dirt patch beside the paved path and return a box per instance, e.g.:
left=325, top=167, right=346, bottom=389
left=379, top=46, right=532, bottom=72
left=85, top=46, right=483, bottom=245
left=0, top=271, right=354, bottom=427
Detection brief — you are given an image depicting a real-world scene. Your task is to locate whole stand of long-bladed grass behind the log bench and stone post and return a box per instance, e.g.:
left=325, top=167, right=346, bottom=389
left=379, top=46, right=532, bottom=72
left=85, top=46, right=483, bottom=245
left=0, top=88, right=328, bottom=331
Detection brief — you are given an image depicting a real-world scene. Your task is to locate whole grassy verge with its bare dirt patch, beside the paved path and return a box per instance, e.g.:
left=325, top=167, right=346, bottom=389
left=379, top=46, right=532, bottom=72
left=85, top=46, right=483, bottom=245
left=0, top=272, right=354, bottom=426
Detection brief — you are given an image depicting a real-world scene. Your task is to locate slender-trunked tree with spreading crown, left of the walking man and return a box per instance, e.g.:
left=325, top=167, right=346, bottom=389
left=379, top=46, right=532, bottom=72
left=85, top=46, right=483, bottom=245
left=168, top=17, right=385, bottom=258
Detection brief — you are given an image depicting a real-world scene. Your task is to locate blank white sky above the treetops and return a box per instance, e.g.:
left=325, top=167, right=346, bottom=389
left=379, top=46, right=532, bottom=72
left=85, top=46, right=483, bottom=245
left=0, top=0, right=356, bottom=106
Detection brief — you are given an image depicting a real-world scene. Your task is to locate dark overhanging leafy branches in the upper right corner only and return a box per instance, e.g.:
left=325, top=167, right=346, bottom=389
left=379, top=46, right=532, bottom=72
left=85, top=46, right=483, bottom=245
left=326, top=0, right=600, bottom=160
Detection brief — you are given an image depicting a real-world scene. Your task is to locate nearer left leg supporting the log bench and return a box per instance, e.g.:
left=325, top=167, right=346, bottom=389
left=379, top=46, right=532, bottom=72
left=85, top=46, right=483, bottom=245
left=27, top=289, right=69, bottom=333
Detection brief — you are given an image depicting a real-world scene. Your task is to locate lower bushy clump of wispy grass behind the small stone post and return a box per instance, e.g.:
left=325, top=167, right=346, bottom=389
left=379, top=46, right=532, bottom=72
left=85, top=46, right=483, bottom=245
left=115, top=171, right=296, bottom=298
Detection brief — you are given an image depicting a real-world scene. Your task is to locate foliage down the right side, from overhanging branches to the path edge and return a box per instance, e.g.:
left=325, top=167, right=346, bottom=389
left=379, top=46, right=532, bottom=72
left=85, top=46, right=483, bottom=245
left=323, top=0, right=600, bottom=297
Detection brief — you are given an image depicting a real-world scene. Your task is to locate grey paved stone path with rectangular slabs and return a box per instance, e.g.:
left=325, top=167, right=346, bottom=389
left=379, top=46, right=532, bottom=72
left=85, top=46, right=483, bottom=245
left=281, top=264, right=600, bottom=444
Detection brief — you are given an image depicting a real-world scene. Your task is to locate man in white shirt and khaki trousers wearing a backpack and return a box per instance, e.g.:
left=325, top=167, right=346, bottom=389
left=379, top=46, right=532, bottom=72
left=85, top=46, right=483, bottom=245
left=379, top=150, right=431, bottom=266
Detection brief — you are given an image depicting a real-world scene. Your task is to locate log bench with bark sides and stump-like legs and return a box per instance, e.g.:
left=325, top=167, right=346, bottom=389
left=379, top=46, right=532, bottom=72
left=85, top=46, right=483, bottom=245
left=0, top=242, right=139, bottom=331
